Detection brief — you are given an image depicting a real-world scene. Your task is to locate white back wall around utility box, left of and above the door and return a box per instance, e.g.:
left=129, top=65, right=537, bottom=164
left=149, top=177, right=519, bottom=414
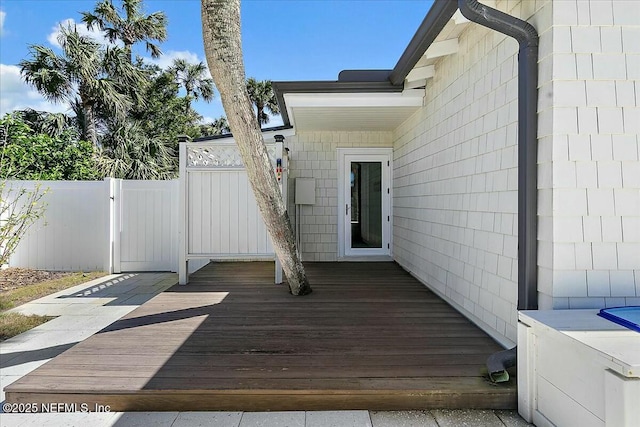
left=285, top=132, right=393, bottom=261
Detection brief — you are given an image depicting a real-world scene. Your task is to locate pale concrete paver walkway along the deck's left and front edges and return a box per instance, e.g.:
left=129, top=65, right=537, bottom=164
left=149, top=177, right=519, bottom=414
left=0, top=273, right=528, bottom=427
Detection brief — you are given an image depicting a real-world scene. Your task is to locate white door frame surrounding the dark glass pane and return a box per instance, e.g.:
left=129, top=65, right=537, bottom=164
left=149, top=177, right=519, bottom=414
left=337, top=148, right=393, bottom=259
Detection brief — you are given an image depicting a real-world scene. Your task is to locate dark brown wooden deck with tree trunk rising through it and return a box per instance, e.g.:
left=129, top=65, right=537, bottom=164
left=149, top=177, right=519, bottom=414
left=6, top=262, right=516, bottom=411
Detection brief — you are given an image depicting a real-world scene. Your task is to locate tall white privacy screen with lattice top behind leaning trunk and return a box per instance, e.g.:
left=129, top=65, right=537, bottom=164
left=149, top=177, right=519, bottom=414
left=178, top=141, right=286, bottom=284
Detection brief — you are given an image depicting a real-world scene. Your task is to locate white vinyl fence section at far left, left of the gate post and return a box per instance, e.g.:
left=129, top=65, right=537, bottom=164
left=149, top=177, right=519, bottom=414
left=9, top=181, right=110, bottom=271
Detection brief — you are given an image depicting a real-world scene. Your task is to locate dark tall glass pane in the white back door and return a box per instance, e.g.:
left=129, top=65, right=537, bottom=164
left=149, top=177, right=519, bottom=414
left=350, top=162, right=382, bottom=248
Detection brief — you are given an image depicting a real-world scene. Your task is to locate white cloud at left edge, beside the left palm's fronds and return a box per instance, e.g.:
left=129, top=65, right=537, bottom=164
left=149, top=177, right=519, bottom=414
left=0, top=64, right=69, bottom=116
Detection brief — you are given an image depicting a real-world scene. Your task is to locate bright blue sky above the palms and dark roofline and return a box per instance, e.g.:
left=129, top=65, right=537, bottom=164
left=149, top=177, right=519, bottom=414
left=0, top=0, right=432, bottom=125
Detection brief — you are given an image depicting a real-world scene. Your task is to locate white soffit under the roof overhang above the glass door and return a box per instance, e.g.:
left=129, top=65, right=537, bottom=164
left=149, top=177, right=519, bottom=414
left=284, top=90, right=424, bottom=131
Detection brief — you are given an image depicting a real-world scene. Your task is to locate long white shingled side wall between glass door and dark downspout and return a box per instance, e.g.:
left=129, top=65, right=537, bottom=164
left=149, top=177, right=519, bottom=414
left=393, top=1, right=551, bottom=344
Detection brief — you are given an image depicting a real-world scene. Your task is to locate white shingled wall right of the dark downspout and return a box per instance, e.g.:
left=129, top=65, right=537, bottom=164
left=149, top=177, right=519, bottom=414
left=539, top=0, right=640, bottom=309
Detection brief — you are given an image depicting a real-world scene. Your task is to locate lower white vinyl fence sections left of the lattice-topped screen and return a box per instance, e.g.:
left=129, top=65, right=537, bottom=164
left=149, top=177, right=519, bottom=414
left=4, top=178, right=178, bottom=273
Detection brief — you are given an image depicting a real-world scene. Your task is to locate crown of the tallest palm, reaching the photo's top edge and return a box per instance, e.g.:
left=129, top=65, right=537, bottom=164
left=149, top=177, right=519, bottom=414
left=82, top=0, right=167, bottom=63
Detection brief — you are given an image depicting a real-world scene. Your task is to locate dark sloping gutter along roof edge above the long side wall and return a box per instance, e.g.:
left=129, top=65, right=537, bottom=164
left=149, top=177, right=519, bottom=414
left=389, top=0, right=458, bottom=85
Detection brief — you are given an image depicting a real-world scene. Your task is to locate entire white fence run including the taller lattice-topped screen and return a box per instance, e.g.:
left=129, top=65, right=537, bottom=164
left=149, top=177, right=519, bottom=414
left=3, top=142, right=287, bottom=276
